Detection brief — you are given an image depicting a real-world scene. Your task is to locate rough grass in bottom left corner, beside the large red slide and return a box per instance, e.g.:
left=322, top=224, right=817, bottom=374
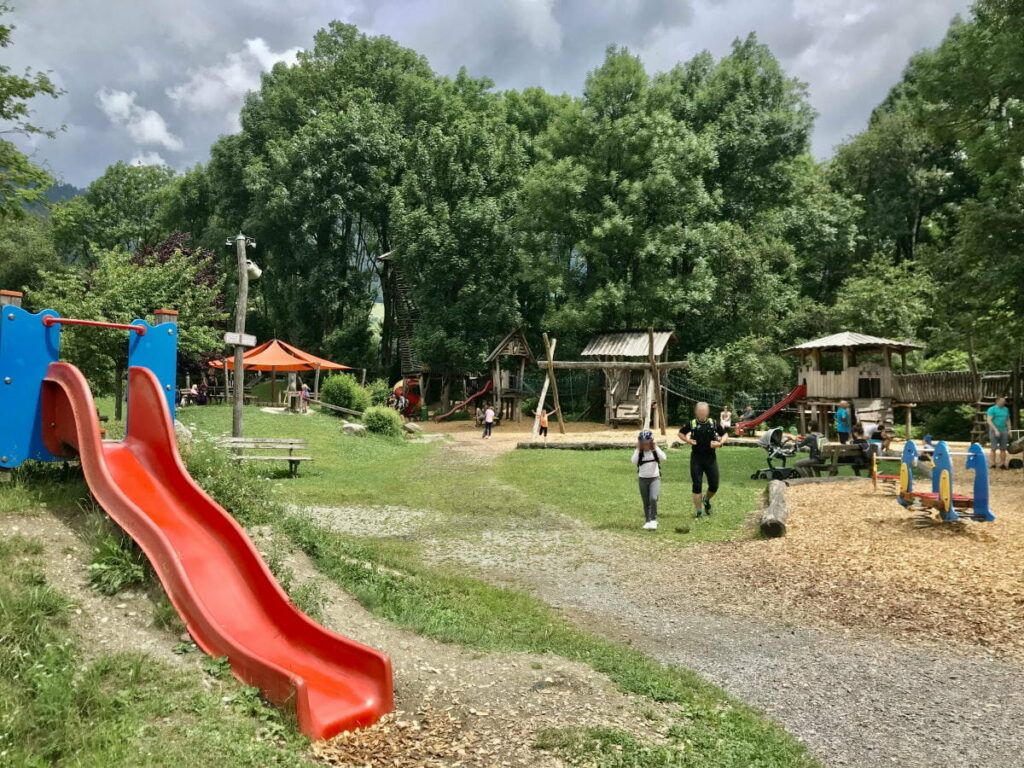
left=0, top=536, right=312, bottom=768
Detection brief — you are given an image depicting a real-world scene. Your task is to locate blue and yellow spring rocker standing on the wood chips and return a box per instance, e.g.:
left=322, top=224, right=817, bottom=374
left=897, top=440, right=995, bottom=522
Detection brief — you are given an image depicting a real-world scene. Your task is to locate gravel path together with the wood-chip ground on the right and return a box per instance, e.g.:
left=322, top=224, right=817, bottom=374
left=299, top=436, right=1024, bottom=768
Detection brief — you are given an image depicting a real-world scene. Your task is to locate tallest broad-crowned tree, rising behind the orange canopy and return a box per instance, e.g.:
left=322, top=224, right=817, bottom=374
left=207, top=23, right=438, bottom=370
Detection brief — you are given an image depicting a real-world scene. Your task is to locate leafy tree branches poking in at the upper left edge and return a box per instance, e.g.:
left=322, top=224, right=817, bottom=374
left=0, top=0, right=61, bottom=218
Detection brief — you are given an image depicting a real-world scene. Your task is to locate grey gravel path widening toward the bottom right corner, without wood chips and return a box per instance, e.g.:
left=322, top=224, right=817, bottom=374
left=301, top=436, right=1024, bottom=768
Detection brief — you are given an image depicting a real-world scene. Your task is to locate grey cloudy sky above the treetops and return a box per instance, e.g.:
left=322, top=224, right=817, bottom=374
left=2, top=0, right=970, bottom=185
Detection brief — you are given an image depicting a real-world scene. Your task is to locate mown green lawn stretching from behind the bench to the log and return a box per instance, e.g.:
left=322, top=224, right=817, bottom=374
left=178, top=406, right=856, bottom=544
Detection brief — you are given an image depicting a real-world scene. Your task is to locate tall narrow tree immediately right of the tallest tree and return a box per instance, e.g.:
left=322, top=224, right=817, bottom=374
left=395, top=73, right=525, bottom=406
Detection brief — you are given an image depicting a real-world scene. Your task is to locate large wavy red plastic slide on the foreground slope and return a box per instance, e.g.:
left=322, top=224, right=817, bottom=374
left=43, top=362, right=393, bottom=738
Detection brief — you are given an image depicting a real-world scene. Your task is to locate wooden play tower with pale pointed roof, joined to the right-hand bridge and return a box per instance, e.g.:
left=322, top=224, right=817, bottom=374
left=783, top=331, right=922, bottom=432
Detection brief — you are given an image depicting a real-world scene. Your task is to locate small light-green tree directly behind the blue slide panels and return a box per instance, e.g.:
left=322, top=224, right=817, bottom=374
left=35, top=250, right=225, bottom=420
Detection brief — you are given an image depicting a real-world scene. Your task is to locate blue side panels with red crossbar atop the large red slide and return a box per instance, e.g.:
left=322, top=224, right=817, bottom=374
left=0, top=304, right=178, bottom=469
